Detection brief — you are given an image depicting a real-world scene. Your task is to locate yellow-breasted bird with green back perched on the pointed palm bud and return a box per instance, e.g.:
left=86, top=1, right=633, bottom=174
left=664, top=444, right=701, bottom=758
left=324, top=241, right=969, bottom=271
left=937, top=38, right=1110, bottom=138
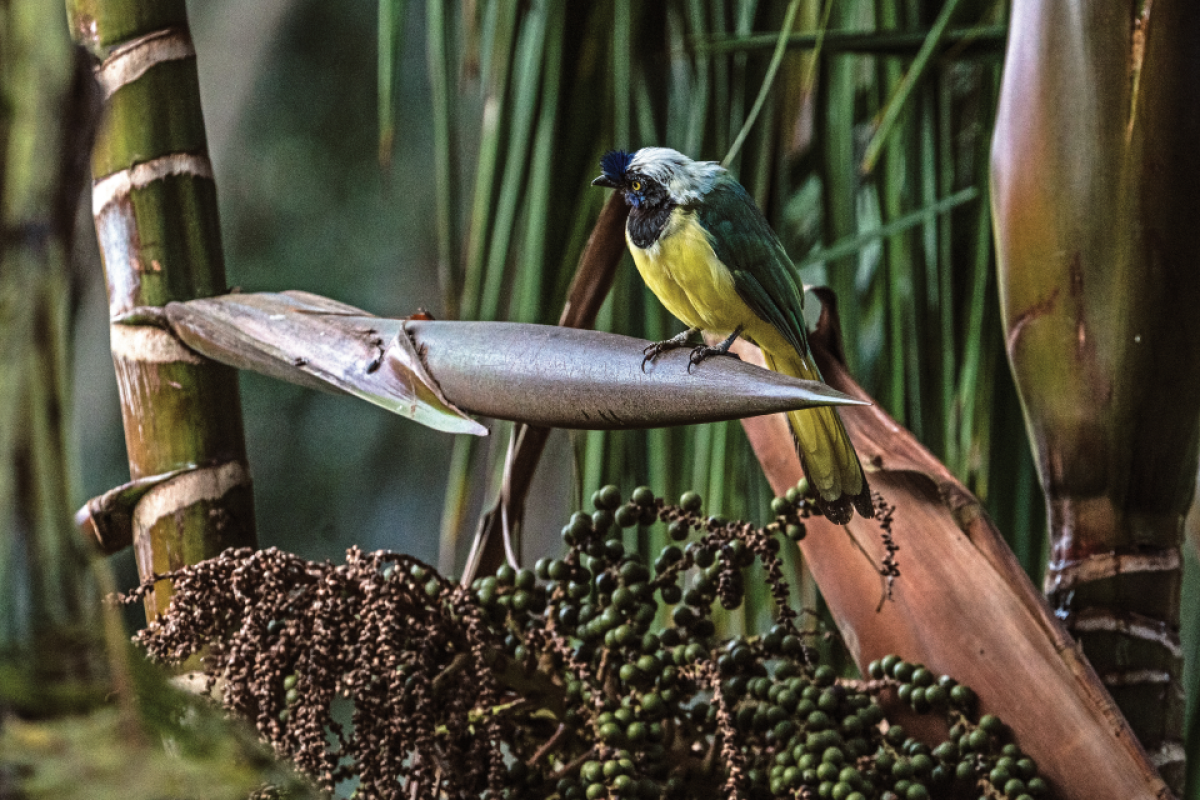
left=592, top=148, right=875, bottom=524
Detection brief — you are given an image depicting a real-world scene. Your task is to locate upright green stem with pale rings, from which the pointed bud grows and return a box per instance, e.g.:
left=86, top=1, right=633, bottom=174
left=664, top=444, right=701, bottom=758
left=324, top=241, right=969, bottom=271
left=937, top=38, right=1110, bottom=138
left=67, top=0, right=254, bottom=618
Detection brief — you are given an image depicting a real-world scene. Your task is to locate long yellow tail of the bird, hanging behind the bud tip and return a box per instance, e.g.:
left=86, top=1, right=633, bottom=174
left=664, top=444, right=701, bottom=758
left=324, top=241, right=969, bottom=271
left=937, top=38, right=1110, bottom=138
left=763, top=350, right=875, bottom=525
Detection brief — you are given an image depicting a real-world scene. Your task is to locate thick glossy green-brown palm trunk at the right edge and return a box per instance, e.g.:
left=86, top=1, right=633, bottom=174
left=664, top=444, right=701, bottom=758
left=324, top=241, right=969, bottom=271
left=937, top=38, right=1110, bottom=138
left=992, top=0, right=1200, bottom=790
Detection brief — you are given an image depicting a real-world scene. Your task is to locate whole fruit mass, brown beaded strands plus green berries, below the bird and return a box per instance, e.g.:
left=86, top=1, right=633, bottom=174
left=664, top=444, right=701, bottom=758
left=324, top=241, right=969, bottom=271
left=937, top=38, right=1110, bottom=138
left=130, top=482, right=1049, bottom=800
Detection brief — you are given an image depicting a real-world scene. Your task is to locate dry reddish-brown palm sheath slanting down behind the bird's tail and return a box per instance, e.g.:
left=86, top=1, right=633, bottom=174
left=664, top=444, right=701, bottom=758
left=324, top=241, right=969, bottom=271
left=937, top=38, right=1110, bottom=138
left=737, top=293, right=1171, bottom=800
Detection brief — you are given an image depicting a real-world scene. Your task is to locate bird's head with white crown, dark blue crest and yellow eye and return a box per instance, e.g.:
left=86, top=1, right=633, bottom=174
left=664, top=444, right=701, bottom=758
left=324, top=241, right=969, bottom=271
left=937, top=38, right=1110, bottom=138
left=592, top=148, right=725, bottom=210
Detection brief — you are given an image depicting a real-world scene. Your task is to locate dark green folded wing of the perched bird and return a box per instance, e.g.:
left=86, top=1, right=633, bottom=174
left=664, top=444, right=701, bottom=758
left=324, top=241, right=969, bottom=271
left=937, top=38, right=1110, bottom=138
left=696, top=176, right=809, bottom=355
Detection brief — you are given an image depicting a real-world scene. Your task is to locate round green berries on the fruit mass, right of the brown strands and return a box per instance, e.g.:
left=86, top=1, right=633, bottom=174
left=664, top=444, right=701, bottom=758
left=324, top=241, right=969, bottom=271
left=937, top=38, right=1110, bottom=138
left=463, top=485, right=1045, bottom=800
